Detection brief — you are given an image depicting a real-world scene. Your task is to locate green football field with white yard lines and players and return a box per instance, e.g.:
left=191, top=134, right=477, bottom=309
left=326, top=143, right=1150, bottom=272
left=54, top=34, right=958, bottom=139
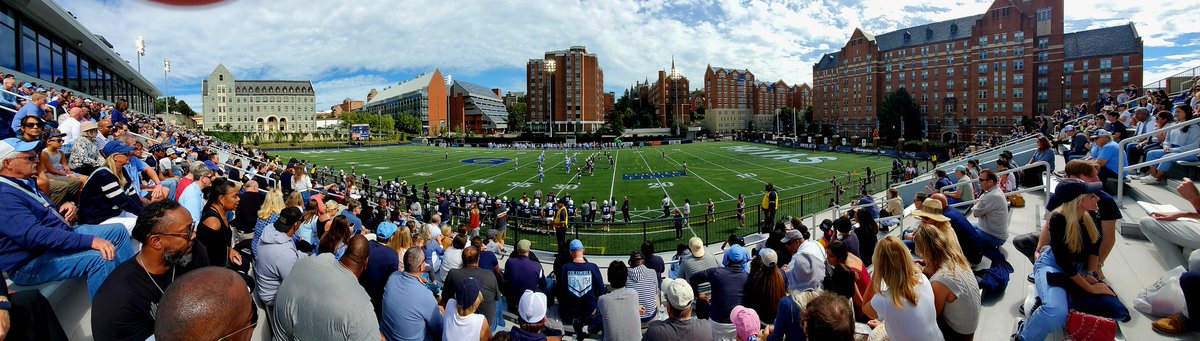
left=280, top=142, right=890, bottom=216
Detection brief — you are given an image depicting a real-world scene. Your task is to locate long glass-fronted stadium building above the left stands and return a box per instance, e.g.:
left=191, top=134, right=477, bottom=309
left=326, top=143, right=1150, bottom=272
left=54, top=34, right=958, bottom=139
left=0, top=0, right=162, bottom=113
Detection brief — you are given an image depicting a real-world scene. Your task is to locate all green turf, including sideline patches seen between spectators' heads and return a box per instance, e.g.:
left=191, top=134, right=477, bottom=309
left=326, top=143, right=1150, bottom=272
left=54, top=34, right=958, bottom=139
left=278, top=142, right=890, bottom=255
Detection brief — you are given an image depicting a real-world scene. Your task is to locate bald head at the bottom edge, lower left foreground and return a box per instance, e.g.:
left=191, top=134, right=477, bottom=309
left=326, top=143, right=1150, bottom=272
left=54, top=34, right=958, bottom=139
left=154, top=267, right=253, bottom=340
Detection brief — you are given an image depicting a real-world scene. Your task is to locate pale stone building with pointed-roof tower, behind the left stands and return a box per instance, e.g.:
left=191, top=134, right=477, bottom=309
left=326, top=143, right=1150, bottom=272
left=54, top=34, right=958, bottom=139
left=202, top=64, right=317, bottom=132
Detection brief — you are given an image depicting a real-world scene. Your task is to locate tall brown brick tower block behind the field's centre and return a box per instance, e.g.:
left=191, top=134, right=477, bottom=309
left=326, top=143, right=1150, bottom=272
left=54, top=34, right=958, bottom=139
left=526, top=46, right=606, bottom=134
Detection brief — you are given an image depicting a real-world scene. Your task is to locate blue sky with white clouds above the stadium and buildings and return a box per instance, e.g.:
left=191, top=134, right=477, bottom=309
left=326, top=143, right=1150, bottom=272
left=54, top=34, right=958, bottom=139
left=59, top=0, right=1200, bottom=112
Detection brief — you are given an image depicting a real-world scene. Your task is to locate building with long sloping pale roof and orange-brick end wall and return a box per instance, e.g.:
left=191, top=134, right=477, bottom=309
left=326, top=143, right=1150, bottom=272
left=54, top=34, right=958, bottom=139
left=362, top=68, right=449, bottom=136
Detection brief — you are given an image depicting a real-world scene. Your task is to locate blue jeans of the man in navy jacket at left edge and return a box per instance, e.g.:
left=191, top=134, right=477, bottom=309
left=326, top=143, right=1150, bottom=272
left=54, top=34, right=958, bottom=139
left=8, top=223, right=134, bottom=298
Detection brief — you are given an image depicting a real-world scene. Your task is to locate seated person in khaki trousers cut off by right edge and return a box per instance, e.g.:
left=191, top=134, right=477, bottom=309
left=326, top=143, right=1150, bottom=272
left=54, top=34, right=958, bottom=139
left=1139, top=178, right=1200, bottom=271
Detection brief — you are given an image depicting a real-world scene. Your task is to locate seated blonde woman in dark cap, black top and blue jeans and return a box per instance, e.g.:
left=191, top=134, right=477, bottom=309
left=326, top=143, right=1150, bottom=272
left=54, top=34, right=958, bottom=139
left=1016, top=179, right=1130, bottom=340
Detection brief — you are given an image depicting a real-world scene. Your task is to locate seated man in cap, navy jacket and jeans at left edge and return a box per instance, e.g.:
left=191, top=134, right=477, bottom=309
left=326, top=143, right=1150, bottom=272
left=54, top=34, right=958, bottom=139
left=0, top=138, right=133, bottom=297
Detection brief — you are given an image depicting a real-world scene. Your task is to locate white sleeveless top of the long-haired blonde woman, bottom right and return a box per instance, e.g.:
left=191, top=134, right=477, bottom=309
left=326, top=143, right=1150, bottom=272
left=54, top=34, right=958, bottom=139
left=871, top=274, right=944, bottom=341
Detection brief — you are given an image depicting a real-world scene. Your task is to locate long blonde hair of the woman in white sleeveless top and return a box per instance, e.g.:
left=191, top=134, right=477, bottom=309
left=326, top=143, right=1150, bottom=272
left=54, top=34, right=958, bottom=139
left=871, top=237, right=924, bottom=309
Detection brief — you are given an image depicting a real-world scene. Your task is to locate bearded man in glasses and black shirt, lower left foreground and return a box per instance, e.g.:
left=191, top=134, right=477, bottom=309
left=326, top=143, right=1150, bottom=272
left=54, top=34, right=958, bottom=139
left=91, top=201, right=209, bottom=340
